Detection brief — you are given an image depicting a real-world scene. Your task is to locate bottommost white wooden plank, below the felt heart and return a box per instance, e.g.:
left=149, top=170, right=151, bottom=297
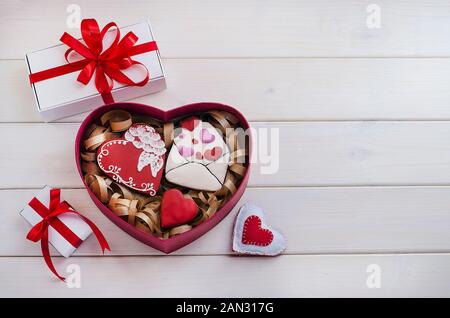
left=0, top=254, right=450, bottom=297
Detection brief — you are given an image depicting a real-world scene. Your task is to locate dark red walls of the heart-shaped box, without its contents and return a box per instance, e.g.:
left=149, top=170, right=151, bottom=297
left=75, top=102, right=252, bottom=254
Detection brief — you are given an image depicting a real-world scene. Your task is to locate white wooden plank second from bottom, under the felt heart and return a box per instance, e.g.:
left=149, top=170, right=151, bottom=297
left=4, top=187, right=450, bottom=256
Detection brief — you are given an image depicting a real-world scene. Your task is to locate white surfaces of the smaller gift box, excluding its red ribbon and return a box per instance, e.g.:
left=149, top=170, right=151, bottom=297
left=20, top=186, right=92, bottom=257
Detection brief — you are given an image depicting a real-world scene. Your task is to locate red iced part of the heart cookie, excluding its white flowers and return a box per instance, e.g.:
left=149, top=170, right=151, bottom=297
left=97, top=124, right=165, bottom=196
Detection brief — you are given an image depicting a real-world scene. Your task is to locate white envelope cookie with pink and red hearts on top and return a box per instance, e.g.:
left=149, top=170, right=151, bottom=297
left=166, top=117, right=230, bottom=191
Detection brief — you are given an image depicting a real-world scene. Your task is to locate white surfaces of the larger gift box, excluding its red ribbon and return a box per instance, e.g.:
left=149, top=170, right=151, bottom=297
left=26, top=21, right=166, bottom=121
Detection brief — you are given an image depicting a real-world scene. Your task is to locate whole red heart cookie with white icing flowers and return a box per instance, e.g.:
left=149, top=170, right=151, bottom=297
left=97, top=124, right=166, bottom=196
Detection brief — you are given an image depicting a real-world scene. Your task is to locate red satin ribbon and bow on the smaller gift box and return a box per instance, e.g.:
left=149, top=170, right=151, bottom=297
left=27, top=189, right=111, bottom=281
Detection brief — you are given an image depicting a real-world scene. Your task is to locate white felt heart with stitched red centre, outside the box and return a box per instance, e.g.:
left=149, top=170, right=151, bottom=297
left=233, top=203, right=286, bottom=256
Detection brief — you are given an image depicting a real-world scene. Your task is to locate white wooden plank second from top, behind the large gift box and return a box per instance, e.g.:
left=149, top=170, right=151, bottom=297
left=4, top=58, right=450, bottom=122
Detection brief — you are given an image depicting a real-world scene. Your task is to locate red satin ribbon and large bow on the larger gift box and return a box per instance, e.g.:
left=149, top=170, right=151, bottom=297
left=29, top=19, right=158, bottom=103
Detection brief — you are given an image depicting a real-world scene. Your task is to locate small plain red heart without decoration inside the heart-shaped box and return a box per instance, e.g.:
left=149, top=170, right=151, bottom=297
left=161, top=189, right=198, bottom=228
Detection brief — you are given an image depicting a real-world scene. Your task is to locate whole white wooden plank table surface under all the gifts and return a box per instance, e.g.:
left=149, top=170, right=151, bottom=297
left=0, top=0, right=450, bottom=297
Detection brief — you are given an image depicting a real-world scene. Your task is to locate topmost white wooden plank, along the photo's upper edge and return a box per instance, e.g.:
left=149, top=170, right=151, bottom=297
left=0, top=0, right=450, bottom=59
